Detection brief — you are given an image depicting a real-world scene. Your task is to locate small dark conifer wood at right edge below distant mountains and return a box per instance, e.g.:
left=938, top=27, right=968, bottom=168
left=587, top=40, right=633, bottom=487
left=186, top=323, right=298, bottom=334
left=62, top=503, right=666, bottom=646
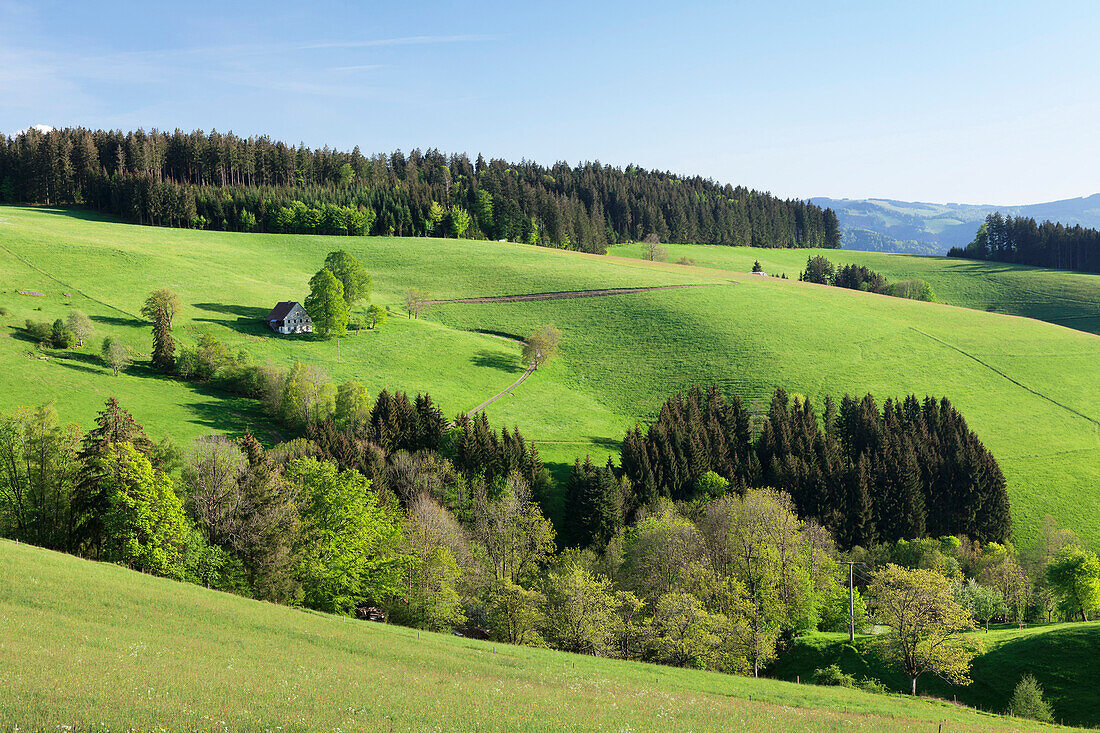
left=947, top=211, right=1100, bottom=277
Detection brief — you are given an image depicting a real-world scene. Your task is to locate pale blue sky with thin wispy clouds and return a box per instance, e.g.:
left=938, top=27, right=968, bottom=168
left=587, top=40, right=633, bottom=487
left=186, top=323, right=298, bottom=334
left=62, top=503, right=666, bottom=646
left=0, top=0, right=1100, bottom=205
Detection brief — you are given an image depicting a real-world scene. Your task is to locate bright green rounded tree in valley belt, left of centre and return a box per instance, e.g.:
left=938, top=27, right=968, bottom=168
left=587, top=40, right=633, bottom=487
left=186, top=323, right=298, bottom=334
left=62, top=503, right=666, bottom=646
left=287, top=458, right=403, bottom=613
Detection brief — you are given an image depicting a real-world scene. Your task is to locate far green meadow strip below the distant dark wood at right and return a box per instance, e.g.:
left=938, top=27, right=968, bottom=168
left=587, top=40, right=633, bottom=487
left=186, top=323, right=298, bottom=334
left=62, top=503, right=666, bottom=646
left=609, top=244, right=1100, bottom=333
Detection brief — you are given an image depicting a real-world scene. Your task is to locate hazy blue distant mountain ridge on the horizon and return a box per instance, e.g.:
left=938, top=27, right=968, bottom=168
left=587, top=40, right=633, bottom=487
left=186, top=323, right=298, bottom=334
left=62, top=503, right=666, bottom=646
left=810, top=194, right=1100, bottom=254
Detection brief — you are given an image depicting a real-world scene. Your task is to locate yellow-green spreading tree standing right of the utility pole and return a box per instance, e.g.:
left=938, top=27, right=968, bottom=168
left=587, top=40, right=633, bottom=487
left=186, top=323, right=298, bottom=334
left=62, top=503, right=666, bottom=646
left=868, top=564, right=978, bottom=694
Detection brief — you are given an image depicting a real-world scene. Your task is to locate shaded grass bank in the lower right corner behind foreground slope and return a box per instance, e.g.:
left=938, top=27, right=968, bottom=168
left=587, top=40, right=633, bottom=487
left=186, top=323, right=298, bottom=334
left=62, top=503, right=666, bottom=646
left=770, top=622, right=1100, bottom=727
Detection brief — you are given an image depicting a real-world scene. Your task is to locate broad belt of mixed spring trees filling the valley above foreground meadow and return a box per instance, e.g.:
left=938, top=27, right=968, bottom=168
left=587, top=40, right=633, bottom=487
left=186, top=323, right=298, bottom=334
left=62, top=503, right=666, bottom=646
left=0, top=393, right=1100, bottom=704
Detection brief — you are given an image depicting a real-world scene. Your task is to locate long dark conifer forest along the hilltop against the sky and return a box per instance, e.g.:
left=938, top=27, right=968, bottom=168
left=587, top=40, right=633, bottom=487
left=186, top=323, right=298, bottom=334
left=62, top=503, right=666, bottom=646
left=0, top=128, right=840, bottom=252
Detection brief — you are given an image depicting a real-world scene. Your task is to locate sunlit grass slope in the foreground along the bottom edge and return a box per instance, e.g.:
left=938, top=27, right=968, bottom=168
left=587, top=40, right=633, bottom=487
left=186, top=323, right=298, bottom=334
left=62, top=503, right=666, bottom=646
left=0, top=540, right=1069, bottom=733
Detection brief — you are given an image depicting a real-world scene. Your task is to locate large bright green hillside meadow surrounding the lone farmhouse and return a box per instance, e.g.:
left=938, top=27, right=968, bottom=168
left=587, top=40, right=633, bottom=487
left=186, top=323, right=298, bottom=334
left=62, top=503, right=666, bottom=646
left=0, top=207, right=1100, bottom=543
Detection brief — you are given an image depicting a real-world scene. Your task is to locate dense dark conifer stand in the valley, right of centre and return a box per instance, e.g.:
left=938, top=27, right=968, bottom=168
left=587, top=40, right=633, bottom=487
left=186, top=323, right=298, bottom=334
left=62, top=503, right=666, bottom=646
left=616, top=386, right=1012, bottom=547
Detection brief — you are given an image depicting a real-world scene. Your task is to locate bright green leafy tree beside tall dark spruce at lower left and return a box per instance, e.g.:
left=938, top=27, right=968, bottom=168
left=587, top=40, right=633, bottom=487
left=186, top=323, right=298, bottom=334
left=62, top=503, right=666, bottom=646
left=101, top=442, right=188, bottom=578
